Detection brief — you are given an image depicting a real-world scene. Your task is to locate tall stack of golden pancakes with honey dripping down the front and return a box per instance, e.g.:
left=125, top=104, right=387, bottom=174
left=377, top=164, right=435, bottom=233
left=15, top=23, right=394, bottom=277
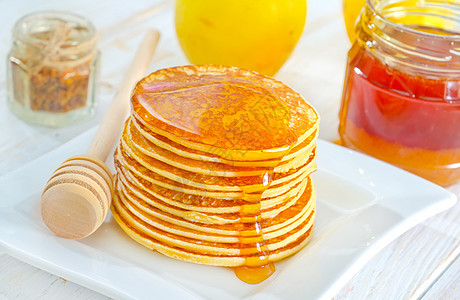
left=112, top=65, right=319, bottom=283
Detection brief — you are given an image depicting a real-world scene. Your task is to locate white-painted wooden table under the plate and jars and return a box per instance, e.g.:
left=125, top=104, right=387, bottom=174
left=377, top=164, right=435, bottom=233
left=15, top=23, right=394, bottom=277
left=0, top=0, right=460, bottom=300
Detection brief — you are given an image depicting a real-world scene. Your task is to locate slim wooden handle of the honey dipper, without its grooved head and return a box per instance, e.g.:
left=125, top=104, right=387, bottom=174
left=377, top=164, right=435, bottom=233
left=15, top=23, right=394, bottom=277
left=86, top=30, right=160, bottom=161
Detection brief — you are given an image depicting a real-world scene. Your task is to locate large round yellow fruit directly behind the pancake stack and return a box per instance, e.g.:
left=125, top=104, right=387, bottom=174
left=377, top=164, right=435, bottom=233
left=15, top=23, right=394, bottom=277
left=175, top=0, right=307, bottom=75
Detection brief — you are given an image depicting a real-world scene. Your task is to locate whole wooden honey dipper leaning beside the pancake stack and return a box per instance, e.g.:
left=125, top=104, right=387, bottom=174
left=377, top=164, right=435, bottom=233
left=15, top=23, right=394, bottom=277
left=41, top=30, right=160, bottom=239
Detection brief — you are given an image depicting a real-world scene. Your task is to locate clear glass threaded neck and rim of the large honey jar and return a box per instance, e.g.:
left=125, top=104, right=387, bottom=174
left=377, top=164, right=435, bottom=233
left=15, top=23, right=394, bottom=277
left=357, top=0, right=460, bottom=78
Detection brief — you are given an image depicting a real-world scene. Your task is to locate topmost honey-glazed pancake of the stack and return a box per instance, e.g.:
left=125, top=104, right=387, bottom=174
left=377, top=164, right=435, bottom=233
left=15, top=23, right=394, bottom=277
left=132, top=65, right=319, bottom=161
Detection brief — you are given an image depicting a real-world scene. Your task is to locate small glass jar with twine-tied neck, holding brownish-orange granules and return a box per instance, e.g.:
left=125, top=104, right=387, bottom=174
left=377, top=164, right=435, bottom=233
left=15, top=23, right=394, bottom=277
left=7, top=12, right=99, bottom=127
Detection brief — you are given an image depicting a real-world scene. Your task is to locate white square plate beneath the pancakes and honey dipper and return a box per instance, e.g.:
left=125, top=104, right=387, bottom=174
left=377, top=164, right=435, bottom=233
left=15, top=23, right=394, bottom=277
left=0, top=129, right=456, bottom=299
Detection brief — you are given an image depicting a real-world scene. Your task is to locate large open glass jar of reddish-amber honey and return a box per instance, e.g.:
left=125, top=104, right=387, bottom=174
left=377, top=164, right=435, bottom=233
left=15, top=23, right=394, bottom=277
left=339, top=0, right=460, bottom=186
